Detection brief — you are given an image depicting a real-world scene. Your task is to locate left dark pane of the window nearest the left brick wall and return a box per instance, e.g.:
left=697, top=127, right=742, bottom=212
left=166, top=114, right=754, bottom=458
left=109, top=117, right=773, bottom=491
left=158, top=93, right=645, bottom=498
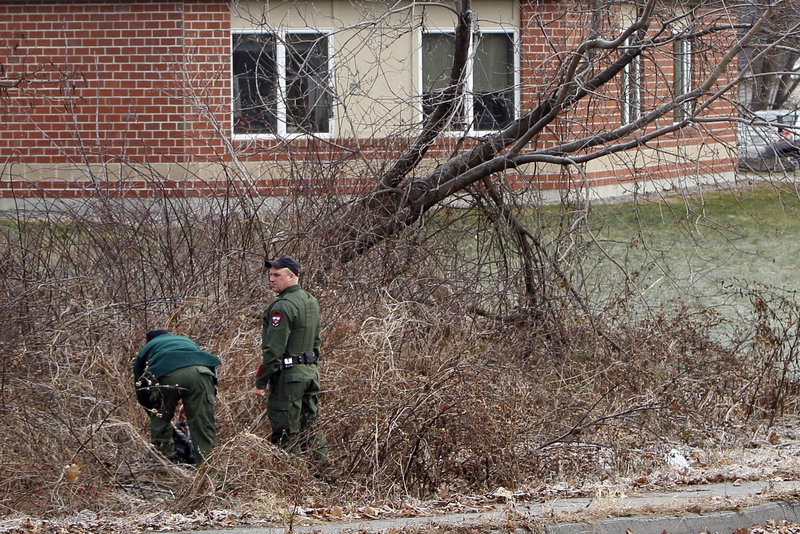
left=232, top=33, right=278, bottom=133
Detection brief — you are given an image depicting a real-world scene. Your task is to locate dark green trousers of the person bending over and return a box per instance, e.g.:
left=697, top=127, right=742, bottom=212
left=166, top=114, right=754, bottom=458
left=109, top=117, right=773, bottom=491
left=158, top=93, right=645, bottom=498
left=150, top=365, right=217, bottom=463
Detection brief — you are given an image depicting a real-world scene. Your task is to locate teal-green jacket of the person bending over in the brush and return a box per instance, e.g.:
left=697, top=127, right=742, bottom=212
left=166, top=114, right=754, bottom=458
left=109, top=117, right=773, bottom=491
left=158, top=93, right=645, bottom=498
left=133, top=334, right=222, bottom=406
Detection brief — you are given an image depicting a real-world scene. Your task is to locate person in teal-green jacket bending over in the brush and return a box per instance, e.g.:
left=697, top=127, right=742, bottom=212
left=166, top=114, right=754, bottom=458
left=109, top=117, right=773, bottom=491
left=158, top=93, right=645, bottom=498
left=133, top=330, right=222, bottom=463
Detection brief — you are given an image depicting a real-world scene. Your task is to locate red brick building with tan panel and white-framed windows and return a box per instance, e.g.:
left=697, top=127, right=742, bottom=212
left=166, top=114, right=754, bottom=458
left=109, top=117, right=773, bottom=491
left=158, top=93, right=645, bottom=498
left=0, top=0, right=735, bottom=204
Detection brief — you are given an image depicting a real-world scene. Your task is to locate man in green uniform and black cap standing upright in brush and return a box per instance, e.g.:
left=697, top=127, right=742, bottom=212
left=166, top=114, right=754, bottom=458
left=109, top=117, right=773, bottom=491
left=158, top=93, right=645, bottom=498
left=255, top=255, right=328, bottom=467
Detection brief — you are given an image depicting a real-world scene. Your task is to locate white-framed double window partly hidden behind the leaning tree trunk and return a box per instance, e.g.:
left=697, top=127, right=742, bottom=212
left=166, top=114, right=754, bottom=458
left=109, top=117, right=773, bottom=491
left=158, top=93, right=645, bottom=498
left=421, top=30, right=518, bottom=131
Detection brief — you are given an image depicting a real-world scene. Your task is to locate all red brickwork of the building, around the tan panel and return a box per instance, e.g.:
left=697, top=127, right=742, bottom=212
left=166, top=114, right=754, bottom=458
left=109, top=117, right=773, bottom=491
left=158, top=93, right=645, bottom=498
left=0, top=0, right=735, bottom=202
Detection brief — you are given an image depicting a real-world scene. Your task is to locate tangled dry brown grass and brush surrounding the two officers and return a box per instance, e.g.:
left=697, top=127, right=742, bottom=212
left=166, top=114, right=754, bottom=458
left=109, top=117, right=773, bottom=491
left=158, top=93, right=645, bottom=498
left=0, top=195, right=797, bottom=521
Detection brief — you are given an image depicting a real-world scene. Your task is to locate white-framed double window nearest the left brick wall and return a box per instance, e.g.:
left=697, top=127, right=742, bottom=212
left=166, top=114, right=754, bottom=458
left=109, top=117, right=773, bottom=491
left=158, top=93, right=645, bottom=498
left=231, top=31, right=333, bottom=136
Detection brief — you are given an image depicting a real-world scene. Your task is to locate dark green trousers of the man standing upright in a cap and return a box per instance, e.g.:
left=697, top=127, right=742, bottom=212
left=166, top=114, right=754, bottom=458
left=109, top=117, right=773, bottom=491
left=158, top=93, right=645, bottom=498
left=267, top=364, right=328, bottom=463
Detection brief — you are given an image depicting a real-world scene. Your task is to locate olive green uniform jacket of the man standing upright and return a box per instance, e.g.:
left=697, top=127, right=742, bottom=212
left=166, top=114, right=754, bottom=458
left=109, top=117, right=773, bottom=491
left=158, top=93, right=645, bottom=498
left=256, top=285, right=321, bottom=389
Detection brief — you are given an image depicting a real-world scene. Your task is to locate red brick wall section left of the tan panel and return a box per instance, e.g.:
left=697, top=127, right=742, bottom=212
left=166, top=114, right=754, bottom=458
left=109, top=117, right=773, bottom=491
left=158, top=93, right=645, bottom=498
left=0, top=1, right=230, bottom=196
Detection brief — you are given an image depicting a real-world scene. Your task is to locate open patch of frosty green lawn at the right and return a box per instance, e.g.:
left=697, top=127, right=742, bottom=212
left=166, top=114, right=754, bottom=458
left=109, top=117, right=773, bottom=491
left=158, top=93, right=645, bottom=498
left=590, top=184, right=800, bottom=315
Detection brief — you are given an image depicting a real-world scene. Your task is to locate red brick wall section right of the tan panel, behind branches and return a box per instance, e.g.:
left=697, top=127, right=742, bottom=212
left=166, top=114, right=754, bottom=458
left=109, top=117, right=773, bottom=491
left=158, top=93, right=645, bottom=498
left=520, top=0, right=736, bottom=195
